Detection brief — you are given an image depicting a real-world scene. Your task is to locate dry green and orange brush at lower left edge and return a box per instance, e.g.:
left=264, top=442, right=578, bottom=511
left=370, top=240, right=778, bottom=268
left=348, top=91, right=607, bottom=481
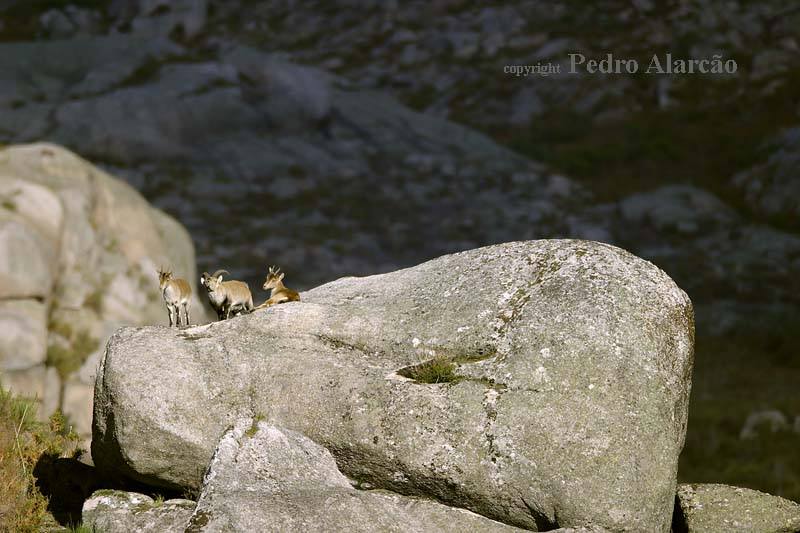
left=0, top=387, right=81, bottom=533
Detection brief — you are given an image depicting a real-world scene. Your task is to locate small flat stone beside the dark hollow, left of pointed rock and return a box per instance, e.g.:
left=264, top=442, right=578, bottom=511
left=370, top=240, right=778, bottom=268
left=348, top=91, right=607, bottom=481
left=81, top=490, right=195, bottom=533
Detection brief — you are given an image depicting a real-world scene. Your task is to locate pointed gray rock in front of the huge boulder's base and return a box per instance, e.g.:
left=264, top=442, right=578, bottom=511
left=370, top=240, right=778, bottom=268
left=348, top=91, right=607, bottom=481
left=186, top=419, right=520, bottom=533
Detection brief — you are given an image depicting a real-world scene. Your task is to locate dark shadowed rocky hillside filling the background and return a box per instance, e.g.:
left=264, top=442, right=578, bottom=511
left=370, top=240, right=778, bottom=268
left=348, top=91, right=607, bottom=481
left=0, top=0, right=800, bottom=499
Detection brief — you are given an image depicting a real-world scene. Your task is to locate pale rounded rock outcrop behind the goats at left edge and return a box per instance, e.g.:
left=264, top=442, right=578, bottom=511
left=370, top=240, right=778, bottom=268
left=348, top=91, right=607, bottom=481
left=0, top=144, right=205, bottom=434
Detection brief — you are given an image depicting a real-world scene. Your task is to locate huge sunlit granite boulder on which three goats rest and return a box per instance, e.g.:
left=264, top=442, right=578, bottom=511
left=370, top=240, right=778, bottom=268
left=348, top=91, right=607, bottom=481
left=92, top=240, right=694, bottom=531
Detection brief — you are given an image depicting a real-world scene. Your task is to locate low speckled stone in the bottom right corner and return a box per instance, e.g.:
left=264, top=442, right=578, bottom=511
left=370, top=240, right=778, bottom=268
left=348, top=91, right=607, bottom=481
left=676, top=483, right=800, bottom=533
